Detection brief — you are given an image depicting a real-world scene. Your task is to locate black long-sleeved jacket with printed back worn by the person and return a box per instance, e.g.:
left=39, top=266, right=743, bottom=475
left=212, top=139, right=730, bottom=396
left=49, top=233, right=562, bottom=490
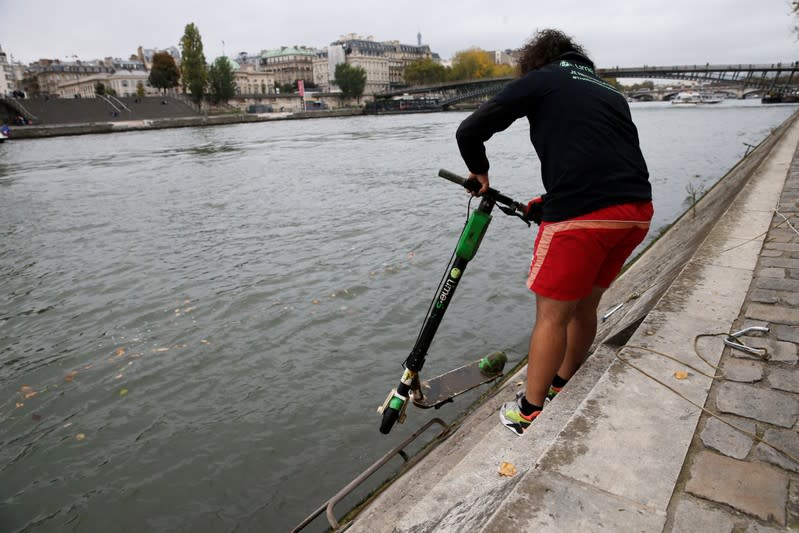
left=456, top=53, right=652, bottom=222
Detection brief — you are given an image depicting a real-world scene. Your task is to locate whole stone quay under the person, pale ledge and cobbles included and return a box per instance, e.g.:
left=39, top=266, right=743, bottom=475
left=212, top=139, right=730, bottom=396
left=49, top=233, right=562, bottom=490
left=350, top=113, right=799, bottom=533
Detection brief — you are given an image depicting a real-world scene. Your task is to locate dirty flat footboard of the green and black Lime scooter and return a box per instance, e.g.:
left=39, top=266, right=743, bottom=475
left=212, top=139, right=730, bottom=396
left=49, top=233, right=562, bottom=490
left=412, top=352, right=508, bottom=409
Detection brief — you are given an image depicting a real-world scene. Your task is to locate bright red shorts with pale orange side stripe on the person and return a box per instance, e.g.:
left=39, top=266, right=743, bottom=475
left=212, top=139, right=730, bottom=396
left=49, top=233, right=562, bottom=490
left=527, top=202, right=653, bottom=300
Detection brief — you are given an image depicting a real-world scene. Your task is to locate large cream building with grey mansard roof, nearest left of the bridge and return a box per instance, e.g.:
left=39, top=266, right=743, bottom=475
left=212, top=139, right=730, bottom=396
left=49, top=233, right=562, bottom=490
left=313, top=33, right=438, bottom=95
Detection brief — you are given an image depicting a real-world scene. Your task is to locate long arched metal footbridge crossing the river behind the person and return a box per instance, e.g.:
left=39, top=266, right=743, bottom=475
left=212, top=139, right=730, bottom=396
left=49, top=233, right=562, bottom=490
left=372, top=61, right=799, bottom=112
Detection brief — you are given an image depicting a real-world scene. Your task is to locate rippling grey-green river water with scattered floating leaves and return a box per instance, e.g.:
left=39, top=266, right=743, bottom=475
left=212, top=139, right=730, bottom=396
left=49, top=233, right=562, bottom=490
left=0, top=101, right=796, bottom=532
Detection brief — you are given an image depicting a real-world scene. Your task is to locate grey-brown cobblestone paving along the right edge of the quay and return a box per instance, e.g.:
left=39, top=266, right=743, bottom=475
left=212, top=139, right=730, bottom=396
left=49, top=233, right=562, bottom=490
left=666, top=133, right=799, bottom=532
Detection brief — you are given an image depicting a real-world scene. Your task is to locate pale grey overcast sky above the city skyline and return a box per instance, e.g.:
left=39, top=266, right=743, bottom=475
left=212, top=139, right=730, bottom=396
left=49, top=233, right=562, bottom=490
left=0, top=0, right=799, bottom=67
